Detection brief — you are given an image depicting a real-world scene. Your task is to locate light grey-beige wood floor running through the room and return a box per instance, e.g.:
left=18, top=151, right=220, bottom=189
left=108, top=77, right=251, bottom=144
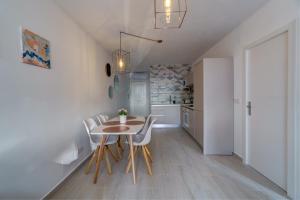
left=49, top=128, right=286, bottom=199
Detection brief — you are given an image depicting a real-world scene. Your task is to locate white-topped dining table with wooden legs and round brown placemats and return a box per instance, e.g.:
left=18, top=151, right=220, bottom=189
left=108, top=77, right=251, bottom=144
left=91, top=116, right=145, bottom=184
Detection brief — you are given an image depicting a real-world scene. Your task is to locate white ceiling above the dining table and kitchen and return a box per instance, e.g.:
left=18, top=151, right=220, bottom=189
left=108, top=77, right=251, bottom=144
left=54, top=0, right=268, bottom=71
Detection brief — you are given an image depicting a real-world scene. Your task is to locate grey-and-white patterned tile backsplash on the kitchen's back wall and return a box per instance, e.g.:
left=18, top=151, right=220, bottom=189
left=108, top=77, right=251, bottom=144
left=150, top=65, right=192, bottom=105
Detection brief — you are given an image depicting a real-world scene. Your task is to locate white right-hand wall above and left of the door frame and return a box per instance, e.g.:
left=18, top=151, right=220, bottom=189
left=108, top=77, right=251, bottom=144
left=195, top=0, right=300, bottom=157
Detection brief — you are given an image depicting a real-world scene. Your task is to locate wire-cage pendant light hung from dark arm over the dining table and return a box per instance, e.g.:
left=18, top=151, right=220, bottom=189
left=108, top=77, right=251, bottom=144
left=112, top=31, right=162, bottom=74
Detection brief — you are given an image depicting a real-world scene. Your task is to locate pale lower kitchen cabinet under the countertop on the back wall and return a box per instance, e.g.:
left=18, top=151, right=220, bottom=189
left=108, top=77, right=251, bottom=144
left=151, top=104, right=180, bottom=127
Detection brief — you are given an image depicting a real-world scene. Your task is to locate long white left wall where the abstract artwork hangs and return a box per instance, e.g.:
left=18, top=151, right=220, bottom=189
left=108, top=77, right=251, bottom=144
left=0, top=0, right=128, bottom=198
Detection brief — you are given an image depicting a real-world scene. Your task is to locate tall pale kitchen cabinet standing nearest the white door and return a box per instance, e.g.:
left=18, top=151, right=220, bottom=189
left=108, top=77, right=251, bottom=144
left=193, top=58, right=234, bottom=155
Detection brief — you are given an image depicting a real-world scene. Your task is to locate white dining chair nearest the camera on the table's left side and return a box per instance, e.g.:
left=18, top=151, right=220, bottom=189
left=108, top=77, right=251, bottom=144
left=83, top=118, right=118, bottom=174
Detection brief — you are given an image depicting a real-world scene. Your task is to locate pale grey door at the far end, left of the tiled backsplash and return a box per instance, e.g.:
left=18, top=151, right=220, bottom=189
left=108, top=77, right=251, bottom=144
left=130, top=81, right=149, bottom=116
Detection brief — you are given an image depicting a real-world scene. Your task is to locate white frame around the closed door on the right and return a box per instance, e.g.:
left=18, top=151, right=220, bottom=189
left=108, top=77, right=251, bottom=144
left=242, top=20, right=300, bottom=198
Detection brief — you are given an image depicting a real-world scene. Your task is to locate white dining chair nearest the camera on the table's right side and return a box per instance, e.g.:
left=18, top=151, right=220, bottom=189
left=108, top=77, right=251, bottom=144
left=126, top=116, right=156, bottom=176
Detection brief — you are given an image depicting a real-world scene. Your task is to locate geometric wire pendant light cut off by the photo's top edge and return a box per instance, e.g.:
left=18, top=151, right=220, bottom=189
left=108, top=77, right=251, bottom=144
left=154, top=0, right=187, bottom=29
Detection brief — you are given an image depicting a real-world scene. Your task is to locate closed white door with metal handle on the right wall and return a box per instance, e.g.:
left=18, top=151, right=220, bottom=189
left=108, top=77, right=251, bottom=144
left=246, top=32, right=288, bottom=190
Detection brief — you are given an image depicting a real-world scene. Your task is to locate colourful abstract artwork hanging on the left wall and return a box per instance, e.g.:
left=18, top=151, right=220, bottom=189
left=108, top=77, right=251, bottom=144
left=21, top=29, right=51, bottom=69
